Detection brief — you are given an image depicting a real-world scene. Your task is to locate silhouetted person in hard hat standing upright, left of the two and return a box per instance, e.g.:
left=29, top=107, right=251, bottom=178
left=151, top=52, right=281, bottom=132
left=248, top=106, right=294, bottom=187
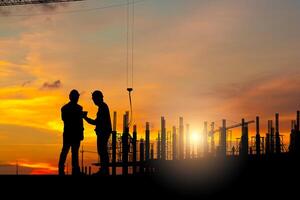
left=58, top=90, right=84, bottom=175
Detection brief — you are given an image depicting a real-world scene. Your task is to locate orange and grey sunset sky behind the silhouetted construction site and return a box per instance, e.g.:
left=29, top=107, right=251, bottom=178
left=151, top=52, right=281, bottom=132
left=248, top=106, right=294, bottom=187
left=0, top=0, right=300, bottom=173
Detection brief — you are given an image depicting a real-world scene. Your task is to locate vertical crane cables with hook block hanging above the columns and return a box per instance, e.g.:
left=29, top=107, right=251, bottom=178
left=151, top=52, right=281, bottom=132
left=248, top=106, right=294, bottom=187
left=126, top=0, right=135, bottom=127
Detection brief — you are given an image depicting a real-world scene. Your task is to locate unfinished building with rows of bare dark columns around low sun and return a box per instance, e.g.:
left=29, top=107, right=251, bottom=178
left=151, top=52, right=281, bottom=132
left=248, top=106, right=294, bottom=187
left=82, top=111, right=300, bottom=175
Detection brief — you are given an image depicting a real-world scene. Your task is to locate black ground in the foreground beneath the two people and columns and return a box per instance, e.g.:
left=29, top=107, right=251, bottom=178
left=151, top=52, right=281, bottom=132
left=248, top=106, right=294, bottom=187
left=0, top=156, right=300, bottom=199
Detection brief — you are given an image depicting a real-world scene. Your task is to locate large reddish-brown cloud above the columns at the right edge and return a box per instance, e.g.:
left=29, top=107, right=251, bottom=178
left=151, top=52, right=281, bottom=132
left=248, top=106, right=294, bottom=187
left=206, top=71, right=300, bottom=119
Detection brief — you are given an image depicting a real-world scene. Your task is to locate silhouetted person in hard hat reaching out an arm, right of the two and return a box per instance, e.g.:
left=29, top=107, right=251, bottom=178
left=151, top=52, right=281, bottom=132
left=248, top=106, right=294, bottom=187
left=84, top=90, right=112, bottom=175
